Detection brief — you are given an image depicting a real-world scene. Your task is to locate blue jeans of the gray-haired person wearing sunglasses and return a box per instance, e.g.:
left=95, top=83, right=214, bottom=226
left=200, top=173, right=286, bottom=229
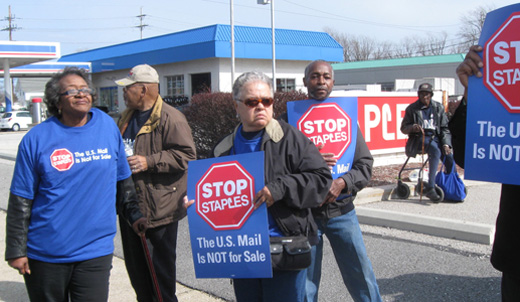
left=233, top=270, right=307, bottom=302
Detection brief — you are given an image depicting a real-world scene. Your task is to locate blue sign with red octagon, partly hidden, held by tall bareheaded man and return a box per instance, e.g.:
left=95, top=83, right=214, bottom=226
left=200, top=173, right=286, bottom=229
left=287, top=97, right=358, bottom=179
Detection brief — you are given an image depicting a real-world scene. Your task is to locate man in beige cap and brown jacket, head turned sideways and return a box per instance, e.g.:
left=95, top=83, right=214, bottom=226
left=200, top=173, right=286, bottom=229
left=116, top=64, right=196, bottom=301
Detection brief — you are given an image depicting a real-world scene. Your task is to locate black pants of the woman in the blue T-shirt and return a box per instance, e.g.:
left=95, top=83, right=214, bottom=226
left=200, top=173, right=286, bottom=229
left=23, top=255, right=112, bottom=302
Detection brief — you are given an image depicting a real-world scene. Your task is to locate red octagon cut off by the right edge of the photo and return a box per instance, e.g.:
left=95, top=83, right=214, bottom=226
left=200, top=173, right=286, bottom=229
left=484, top=12, right=520, bottom=113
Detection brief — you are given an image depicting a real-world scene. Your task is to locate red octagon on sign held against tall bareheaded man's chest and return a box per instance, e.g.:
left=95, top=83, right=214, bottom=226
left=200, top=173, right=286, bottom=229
left=297, top=103, right=352, bottom=158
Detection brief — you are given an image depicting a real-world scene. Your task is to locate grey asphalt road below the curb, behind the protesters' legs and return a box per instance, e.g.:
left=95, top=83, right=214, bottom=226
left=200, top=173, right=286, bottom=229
left=173, top=220, right=500, bottom=302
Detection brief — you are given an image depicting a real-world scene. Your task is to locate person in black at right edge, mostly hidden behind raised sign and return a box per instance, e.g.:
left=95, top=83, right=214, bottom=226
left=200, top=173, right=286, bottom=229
left=450, top=46, right=520, bottom=301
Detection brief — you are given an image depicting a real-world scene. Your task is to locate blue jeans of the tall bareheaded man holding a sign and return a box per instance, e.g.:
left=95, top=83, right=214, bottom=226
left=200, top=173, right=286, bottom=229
left=306, top=210, right=381, bottom=302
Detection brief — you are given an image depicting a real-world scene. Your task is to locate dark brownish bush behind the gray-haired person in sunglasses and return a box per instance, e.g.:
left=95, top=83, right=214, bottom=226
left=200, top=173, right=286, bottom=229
left=183, top=91, right=307, bottom=158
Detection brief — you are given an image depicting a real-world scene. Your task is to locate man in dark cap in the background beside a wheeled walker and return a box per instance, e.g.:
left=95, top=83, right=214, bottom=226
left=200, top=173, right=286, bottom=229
left=401, top=83, right=453, bottom=202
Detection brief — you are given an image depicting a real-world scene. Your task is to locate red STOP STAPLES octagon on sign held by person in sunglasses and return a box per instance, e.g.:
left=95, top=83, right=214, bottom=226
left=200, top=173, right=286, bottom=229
left=196, top=161, right=255, bottom=230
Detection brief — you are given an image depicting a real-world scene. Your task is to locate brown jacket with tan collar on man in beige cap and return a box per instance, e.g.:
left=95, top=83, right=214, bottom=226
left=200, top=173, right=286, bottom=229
left=118, top=96, right=196, bottom=227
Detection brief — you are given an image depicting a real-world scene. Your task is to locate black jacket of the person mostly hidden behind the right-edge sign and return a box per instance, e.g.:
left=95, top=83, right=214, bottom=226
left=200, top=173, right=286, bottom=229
left=450, top=99, right=520, bottom=278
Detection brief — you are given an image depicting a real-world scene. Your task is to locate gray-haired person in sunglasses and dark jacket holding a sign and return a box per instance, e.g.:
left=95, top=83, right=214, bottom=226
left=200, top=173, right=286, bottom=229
left=185, top=71, right=332, bottom=302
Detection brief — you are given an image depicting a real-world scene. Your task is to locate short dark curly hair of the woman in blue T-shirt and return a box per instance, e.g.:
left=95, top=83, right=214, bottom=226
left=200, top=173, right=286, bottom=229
left=44, top=66, right=97, bottom=117
